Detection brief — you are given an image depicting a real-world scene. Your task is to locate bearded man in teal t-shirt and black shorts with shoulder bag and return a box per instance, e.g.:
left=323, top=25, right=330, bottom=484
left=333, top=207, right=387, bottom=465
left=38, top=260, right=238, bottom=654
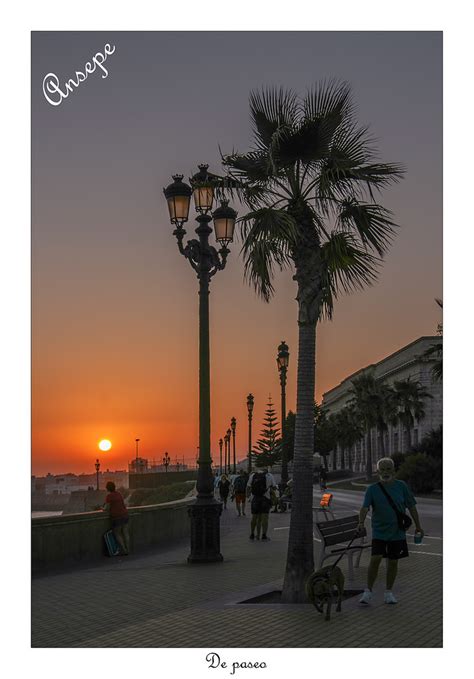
left=359, top=457, right=423, bottom=604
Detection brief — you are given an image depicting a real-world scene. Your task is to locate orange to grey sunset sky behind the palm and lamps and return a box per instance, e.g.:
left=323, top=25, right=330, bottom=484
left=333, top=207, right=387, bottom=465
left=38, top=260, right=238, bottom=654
left=32, top=32, right=443, bottom=475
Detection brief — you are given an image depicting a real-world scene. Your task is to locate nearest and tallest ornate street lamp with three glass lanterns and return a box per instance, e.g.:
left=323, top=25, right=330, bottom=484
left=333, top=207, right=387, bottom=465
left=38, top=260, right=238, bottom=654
left=164, top=165, right=237, bottom=563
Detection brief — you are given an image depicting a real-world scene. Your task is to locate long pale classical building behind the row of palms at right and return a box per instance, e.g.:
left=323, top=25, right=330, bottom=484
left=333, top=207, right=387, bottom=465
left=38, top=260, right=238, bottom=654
left=322, top=335, right=443, bottom=471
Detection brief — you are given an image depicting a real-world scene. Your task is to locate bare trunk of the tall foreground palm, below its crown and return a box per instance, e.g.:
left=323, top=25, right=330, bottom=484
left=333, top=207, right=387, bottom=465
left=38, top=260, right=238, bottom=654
left=282, top=322, right=316, bottom=603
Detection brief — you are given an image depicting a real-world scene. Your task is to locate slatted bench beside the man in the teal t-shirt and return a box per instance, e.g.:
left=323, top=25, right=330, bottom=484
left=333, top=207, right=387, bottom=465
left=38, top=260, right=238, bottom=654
left=314, top=514, right=370, bottom=580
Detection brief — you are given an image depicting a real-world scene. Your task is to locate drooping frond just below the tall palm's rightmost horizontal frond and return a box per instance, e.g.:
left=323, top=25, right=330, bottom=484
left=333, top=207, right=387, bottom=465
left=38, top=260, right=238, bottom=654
left=337, top=199, right=397, bottom=257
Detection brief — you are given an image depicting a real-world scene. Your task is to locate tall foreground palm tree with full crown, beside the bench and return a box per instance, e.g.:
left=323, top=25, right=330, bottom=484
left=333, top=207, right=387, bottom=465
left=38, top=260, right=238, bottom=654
left=223, top=81, right=403, bottom=602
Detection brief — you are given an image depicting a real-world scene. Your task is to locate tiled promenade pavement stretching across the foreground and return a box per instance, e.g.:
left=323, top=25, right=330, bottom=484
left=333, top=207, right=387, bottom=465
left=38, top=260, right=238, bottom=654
left=32, top=507, right=442, bottom=648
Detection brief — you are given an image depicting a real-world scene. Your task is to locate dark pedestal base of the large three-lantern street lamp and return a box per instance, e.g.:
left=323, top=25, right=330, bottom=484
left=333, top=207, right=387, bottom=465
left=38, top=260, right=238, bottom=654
left=188, top=498, right=224, bottom=563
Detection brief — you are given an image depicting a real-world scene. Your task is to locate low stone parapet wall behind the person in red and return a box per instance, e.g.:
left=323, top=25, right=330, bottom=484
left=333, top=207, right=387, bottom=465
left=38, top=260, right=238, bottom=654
left=31, top=499, right=193, bottom=575
